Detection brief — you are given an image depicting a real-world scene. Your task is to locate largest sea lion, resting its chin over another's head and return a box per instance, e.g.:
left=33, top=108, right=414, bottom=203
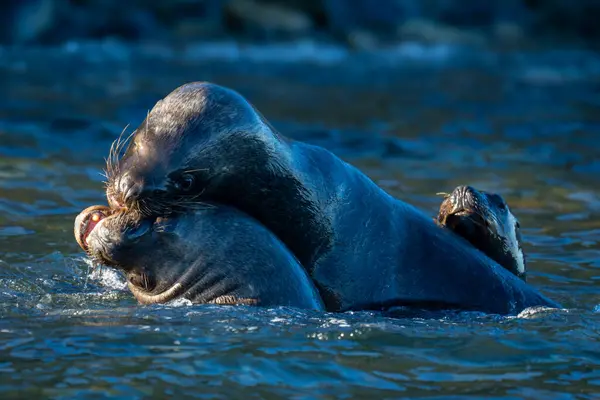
left=107, top=83, right=557, bottom=314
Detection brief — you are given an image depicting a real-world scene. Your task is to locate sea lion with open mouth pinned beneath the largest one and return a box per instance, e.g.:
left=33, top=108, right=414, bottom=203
left=75, top=206, right=323, bottom=310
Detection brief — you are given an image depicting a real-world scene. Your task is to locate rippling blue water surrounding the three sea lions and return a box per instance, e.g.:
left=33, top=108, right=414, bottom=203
left=0, top=42, right=600, bottom=399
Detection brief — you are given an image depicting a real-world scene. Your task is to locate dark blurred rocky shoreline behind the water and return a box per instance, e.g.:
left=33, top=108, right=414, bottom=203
left=0, top=0, right=600, bottom=48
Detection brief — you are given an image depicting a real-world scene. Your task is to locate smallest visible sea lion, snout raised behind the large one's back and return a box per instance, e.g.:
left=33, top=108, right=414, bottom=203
left=436, top=186, right=527, bottom=280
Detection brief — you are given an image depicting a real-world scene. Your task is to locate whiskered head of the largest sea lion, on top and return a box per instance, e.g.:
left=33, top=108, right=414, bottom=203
left=107, top=82, right=290, bottom=215
